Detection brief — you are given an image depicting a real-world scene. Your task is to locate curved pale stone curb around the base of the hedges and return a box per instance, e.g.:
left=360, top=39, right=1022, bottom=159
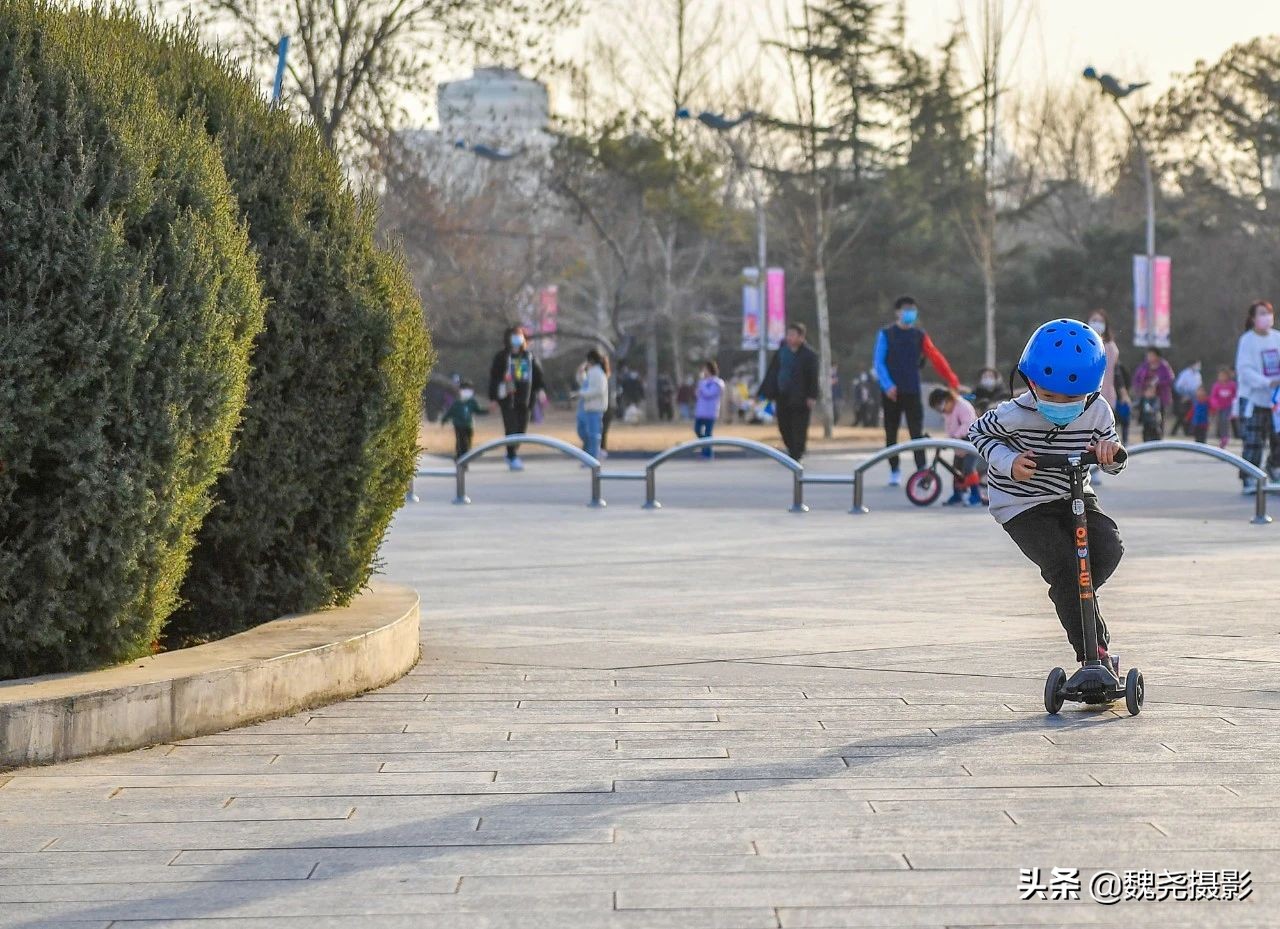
left=0, top=584, right=420, bottom=770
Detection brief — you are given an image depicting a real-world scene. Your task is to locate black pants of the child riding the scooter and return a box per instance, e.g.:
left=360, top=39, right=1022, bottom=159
left=1004, top=496, right=1124, bottom=662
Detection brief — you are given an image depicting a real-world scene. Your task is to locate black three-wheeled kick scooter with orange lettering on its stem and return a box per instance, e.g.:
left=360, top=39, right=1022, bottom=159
left=1036, top=449, right=1144, bottom=717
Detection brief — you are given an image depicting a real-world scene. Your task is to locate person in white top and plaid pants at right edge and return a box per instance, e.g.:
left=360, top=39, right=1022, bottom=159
left=1235, top=299, right=1280, bottom=494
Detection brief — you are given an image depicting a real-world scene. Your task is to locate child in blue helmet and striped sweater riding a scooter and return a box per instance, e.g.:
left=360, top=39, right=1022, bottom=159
left=969, top=319, right=1124, bottom=662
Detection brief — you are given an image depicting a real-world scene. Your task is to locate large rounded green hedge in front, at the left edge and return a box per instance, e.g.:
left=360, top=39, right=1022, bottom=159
left=0, top=0, right=264, bottom=678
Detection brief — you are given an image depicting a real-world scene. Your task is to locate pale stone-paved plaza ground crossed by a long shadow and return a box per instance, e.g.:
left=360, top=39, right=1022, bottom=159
left=0, top=456, right=1280, bottom=929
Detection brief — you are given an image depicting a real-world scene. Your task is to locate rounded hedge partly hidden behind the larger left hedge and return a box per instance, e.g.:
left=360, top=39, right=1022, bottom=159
left=61, top=14, right=431, bottom=645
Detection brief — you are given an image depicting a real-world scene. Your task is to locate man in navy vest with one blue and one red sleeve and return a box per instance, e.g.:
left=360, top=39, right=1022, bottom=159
left=876, top=297, right=960, bottom=488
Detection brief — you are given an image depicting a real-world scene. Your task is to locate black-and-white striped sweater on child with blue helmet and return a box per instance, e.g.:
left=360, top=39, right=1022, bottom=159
left=969, top=392, right=1124, bottom=523
